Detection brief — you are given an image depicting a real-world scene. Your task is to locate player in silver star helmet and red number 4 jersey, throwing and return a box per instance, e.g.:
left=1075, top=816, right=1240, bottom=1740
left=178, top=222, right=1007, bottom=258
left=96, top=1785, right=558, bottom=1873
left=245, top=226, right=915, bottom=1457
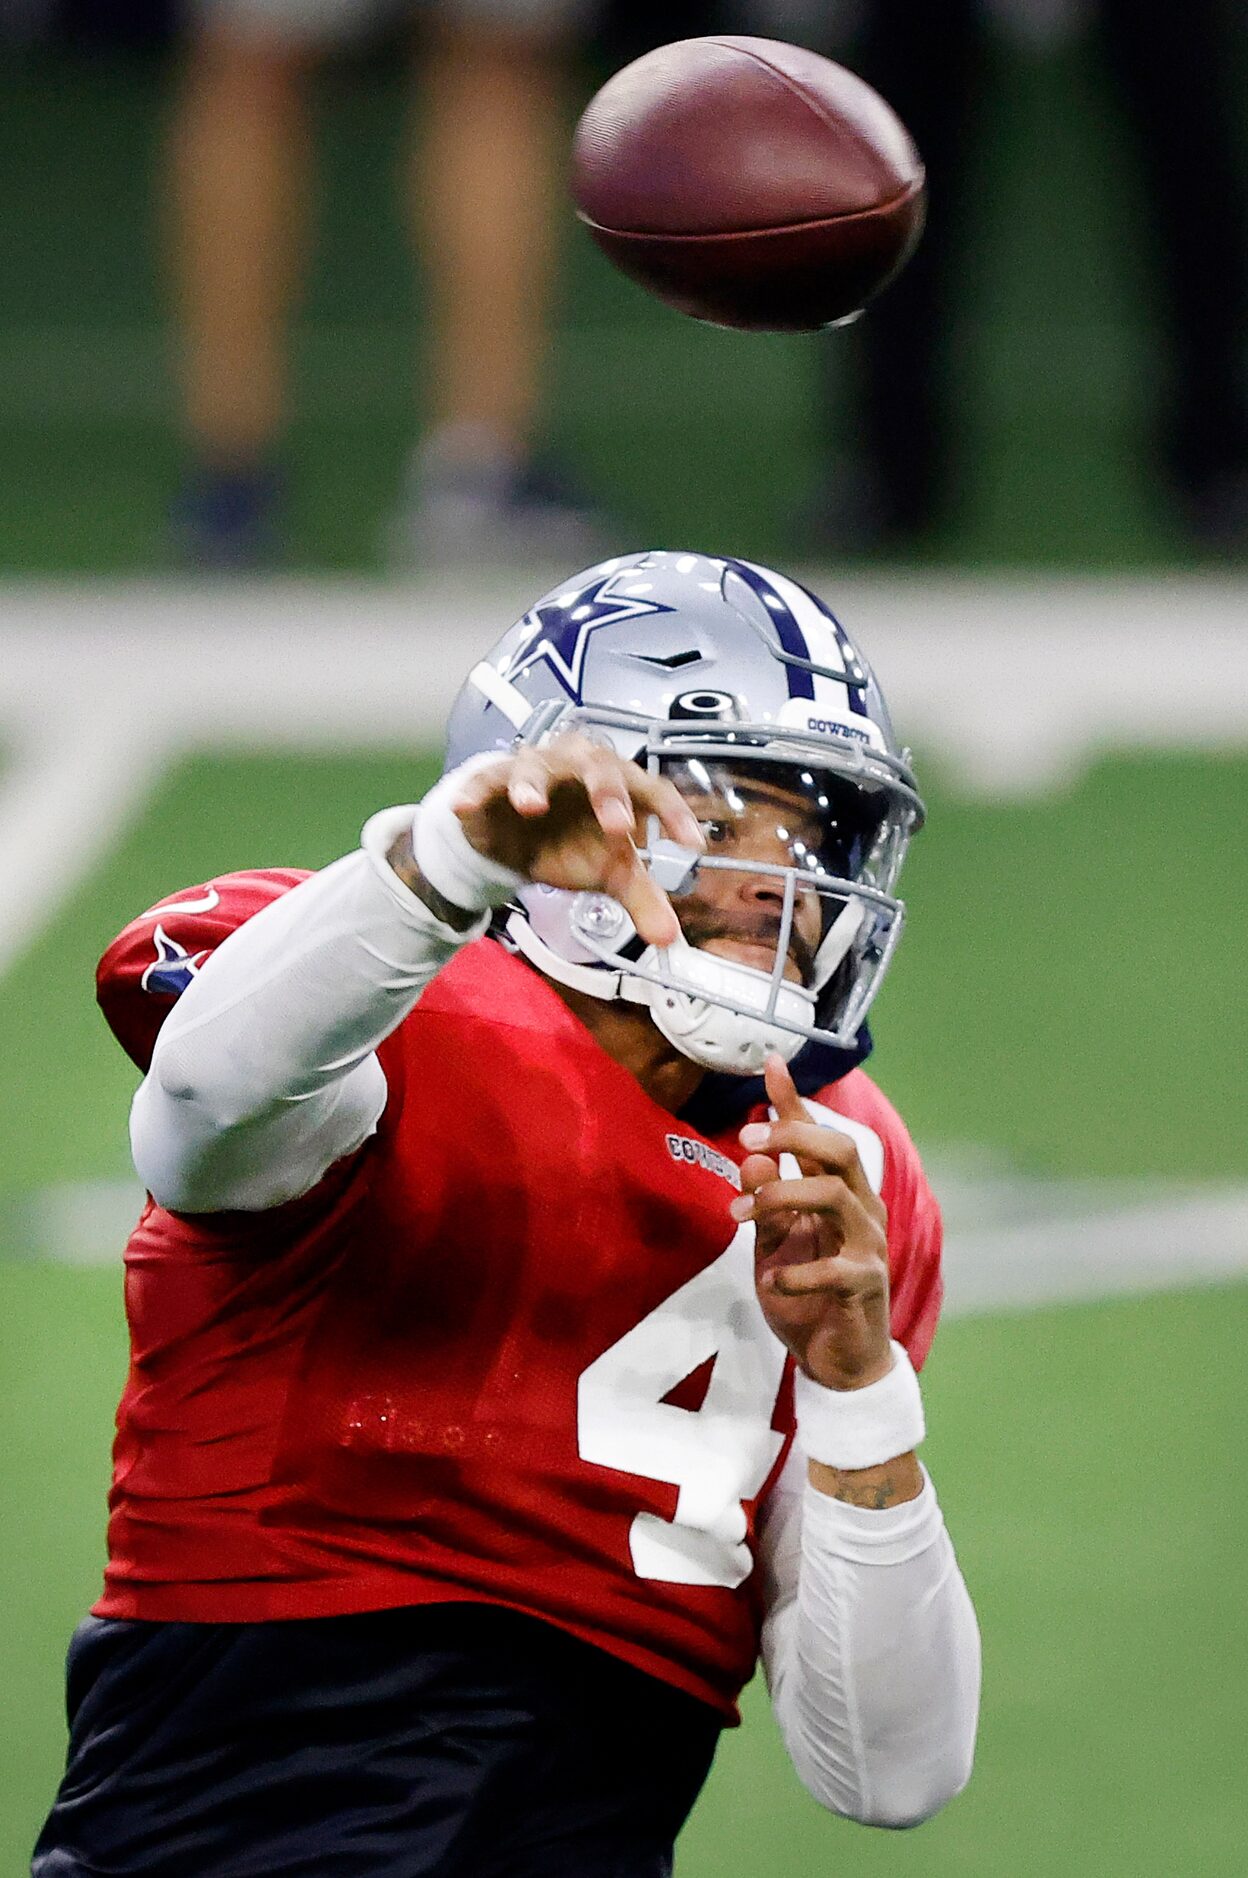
left=34, top=552, right=980, bottom=1878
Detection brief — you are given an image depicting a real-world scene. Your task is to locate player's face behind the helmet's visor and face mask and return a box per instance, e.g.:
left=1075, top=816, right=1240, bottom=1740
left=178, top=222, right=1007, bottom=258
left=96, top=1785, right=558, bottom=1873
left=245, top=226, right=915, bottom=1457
left=670, top=761, right=845, bottom=984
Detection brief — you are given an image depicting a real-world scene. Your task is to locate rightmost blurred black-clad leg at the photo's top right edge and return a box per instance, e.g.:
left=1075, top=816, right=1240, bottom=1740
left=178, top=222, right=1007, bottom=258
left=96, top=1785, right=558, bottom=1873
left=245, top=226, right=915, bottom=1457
left=1100, top=0, right=1248, bottom=554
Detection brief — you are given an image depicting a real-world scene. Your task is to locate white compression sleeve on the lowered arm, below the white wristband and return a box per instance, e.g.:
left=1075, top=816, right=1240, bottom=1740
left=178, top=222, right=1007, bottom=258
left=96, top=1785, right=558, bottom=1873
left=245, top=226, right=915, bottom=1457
left=762, top=1450, right=980, bottom=1825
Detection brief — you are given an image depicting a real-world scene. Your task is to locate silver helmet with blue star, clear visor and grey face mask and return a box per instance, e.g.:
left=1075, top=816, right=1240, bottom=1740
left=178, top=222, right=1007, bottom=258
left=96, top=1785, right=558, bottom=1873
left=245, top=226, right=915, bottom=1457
left=447, top=552, right=923, bottom=1076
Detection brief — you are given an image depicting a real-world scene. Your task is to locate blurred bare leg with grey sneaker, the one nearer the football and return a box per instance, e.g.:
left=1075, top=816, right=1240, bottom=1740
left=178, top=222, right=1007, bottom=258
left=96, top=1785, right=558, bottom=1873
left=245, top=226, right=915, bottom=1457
left=390, top=0, right=602, bottom=565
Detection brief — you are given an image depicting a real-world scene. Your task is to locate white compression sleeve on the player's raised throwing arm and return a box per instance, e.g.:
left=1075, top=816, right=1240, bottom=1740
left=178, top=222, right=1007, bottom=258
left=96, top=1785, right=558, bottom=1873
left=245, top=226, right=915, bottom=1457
left=129, top=808, right=490, bottom=1213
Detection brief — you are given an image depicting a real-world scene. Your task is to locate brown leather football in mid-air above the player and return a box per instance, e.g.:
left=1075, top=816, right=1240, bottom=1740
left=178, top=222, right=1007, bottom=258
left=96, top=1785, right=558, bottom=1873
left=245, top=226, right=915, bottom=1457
left=572, top=34, right=923, bottom=332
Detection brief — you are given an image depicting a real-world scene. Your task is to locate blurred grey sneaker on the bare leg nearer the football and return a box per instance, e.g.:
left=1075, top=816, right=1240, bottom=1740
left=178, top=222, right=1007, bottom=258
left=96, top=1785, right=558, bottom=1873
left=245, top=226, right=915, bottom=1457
left=385, top=426, right=612, bottom=573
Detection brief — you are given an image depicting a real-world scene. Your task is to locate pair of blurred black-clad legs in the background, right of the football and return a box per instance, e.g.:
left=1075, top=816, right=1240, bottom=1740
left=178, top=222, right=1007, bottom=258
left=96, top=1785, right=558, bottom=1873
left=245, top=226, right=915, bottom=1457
left=788, top=0, right=1248, bottom=552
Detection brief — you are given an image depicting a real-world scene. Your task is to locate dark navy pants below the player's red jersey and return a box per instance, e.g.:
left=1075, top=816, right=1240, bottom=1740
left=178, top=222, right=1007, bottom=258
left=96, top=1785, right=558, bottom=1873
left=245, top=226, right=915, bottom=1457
left=32, top=1604, right=721, bottom=1878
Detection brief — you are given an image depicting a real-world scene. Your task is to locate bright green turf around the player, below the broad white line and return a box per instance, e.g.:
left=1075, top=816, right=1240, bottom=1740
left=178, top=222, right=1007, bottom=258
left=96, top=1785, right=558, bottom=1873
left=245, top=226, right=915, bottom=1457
left=0, top=751, right=1248, bottom=1878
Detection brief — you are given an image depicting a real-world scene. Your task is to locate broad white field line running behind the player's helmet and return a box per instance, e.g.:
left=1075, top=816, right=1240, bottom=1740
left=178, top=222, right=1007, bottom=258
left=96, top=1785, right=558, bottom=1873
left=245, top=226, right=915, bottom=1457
left=0, top=571, right=1248, bottom=969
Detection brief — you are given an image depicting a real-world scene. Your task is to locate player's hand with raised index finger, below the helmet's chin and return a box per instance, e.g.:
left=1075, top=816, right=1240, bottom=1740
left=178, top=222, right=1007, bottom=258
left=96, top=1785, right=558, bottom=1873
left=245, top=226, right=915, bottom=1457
left=732, top=1055, right=893, bottom=1390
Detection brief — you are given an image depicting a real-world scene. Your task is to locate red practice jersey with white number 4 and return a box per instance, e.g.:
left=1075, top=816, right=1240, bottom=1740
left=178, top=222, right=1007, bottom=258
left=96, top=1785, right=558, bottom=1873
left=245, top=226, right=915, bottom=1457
left=96, top=871, right=940, bottom=1715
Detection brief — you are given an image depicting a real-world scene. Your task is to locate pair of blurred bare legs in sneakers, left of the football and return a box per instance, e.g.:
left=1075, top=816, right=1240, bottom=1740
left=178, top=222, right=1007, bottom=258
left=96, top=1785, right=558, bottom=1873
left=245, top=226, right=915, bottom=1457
left=173, top=0, right=599, bottom=567
